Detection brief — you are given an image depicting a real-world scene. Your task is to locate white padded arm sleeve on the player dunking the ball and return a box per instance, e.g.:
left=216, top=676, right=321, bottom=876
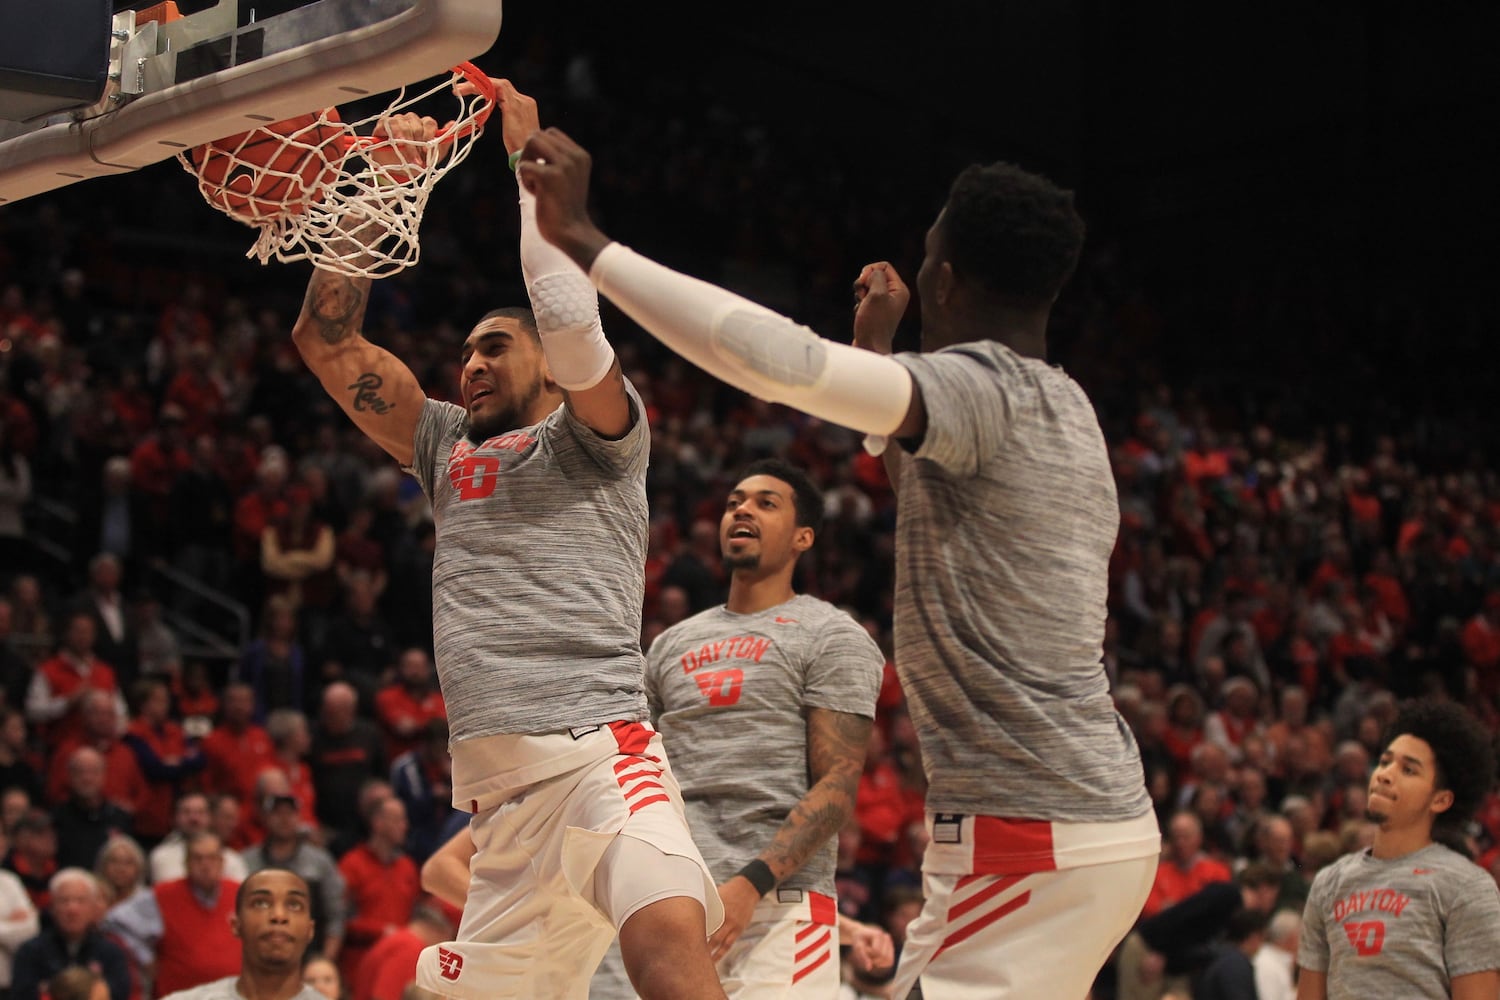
left=518, top=173, right=615, bottom=391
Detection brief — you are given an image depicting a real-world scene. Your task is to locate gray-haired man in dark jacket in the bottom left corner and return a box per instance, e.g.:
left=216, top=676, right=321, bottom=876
left=11, top=868, right=131, bottom=1000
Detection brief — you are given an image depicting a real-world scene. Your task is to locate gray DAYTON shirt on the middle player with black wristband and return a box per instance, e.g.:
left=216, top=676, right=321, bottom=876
left=647, top=595, right=885, bottom=897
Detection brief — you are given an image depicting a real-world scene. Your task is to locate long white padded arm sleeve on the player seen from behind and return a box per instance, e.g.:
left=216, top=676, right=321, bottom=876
left=590, top=243, right=912, bottom=435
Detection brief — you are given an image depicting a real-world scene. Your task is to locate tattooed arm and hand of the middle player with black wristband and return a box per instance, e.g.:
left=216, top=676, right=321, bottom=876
left=708, top=708, right=875, bottom=963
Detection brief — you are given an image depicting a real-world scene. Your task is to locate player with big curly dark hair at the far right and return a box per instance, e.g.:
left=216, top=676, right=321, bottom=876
left=1298, top=702, right=1500, bottom=1000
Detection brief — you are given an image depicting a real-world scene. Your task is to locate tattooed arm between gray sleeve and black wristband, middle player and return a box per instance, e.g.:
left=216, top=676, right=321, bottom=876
left=761, top=709, right=873, bottom=882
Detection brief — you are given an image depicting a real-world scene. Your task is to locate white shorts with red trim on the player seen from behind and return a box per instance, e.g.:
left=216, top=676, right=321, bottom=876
left=891, top=813, right=1161, bottom=1000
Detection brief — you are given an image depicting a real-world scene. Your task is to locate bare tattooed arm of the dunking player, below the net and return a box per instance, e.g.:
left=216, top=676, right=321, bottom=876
left=293, top=268, right=426, bottom=465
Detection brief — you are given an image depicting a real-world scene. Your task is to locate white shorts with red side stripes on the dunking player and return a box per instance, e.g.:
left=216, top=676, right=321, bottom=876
left=417, top=723, right=723, bottom=1000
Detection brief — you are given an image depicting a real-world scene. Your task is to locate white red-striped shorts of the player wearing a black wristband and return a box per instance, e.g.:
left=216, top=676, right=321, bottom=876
left=588, top=889, right=839, bottom=1000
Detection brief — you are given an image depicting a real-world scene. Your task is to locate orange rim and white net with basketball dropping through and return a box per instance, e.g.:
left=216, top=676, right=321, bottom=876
left=177, top=63, right=495, bottom=277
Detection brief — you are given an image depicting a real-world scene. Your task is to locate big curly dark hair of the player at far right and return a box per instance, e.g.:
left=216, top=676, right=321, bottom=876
left=1385, top=699, right=1496, bottom=835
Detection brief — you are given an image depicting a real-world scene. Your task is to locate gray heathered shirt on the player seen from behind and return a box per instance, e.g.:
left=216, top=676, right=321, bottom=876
left=896, top=340, right=1151, bottom=822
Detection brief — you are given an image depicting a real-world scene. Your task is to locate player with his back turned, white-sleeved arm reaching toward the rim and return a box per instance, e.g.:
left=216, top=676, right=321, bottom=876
left=519, top=129, right=1161, bottom=1000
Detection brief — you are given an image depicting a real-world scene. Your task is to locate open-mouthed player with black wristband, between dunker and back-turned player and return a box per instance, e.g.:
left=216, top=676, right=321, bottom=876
left=590, top=460, right=885, bottom=1000
